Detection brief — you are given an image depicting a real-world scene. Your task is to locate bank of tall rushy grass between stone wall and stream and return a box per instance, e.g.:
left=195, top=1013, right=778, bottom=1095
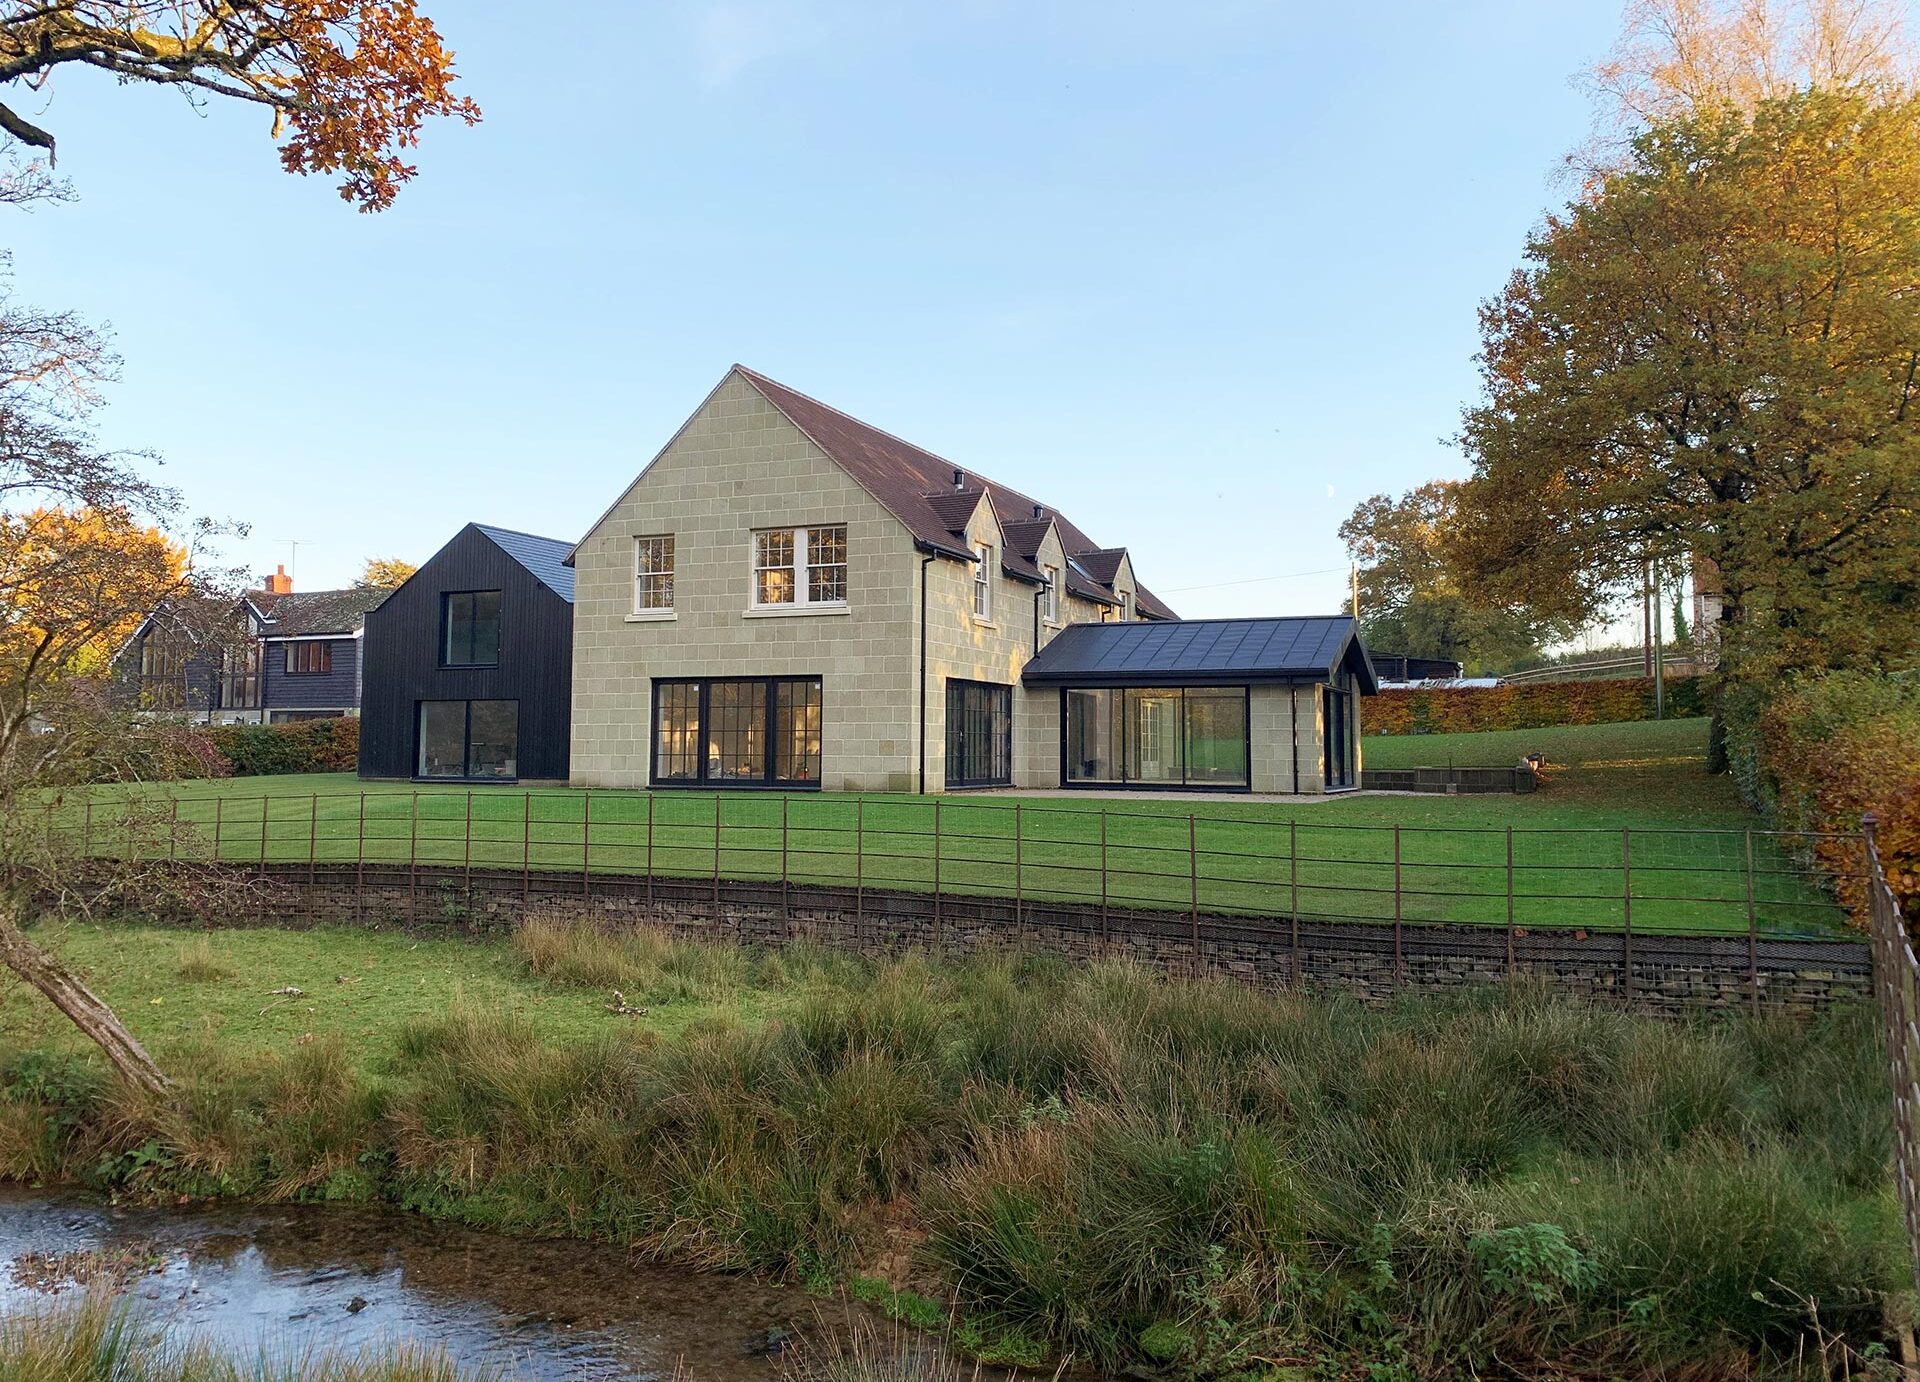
left=0, top=923, right=1908, bottom=1380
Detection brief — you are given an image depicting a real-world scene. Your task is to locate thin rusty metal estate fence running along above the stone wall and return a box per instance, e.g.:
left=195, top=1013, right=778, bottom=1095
left=56, top=789, right=1866, bottom=944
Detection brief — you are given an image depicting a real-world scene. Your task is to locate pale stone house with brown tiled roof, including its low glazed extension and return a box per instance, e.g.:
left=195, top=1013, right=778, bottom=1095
left=568, top=365, right=1375, bottom=793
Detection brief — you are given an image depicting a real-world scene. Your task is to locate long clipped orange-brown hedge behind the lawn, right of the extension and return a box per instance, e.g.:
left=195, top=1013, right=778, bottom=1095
left=1361, top=678, right=1709, bottom=735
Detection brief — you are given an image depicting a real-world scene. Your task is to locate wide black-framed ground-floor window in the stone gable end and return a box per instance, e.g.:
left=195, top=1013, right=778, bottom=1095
left=653, top=678, right=826, bottom=787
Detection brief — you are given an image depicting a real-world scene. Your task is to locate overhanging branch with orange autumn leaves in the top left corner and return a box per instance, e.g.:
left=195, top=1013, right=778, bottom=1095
left=0, top=0, right=480, bottom=211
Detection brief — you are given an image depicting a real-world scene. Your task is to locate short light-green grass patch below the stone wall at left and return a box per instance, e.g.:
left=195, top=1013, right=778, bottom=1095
left=0, top=923, right=760, bottom=1065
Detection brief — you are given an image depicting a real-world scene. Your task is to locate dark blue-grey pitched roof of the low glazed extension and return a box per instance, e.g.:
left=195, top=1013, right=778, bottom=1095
left=1021, top=614, right=1379, bottom=695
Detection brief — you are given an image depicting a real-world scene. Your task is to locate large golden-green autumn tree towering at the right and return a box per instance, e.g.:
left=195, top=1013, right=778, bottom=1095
left=1448, top=88, right=1920, bottom=766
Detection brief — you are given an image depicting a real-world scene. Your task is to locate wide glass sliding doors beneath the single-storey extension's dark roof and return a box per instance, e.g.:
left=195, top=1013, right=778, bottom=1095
left=1062, top=687, right=1250, bottom=787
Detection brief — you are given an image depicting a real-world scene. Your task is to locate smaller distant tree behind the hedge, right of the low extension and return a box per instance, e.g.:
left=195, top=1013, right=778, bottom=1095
left=1340, top=480, right=1569, bottom=674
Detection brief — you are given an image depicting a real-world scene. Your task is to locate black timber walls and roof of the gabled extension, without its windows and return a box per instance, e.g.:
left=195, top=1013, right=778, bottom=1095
left=359, top=524, right=574, bottom=781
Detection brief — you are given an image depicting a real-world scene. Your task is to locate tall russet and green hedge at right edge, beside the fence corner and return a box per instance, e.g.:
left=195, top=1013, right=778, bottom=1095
left=1728, top=672, right=1920, bottom=923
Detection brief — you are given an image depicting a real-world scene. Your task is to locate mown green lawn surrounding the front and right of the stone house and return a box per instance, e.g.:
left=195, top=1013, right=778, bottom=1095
left=75, top=720, right=1837, bottom=933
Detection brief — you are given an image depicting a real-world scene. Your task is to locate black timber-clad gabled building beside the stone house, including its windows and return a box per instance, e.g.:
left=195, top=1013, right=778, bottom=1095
left=359, top=524, right=574, bottom=781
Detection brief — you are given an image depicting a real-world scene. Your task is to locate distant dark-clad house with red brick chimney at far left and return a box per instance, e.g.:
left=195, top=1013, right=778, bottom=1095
left=115, top=566, right=386, bottom=724
